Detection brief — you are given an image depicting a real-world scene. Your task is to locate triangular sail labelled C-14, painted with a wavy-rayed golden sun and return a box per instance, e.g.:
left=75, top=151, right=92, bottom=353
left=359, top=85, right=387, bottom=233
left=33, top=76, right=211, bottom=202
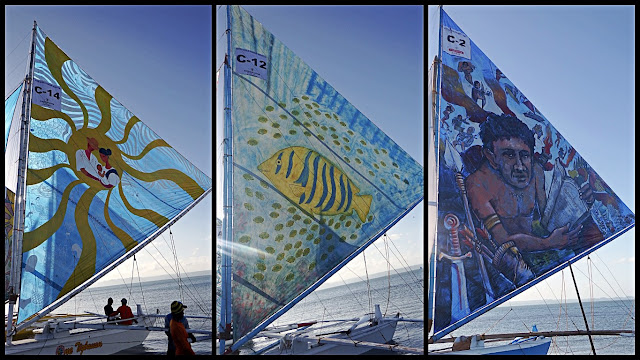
left=13, top=23, right=211, bottom=323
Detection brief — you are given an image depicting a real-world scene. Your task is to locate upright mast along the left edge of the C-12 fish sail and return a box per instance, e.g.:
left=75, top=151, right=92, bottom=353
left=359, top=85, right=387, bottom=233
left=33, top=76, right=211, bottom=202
left=219, top=5, right=233, bottom=355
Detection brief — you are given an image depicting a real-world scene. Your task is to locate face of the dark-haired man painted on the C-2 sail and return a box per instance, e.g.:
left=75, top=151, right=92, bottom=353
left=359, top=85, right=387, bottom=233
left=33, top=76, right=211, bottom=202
left=488, top=137, right=533, bottom=189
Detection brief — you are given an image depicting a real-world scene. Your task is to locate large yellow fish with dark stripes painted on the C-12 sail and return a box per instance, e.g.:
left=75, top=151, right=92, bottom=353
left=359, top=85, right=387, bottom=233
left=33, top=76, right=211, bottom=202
left=258, top=146, right=373, bottom=223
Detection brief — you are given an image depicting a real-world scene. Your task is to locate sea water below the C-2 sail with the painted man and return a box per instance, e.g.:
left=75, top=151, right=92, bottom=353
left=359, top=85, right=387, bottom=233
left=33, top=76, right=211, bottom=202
left=429, top=299, right=635, bottom=355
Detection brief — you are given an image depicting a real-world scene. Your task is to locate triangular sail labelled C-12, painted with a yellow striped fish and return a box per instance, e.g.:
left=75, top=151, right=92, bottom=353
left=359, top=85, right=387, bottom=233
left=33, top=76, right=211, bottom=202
left=230, top=6, right=424, bottom=340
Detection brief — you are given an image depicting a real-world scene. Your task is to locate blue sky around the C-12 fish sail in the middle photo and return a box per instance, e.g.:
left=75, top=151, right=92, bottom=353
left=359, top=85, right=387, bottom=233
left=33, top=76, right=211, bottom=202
left=215, top=6, right=424, bottom=283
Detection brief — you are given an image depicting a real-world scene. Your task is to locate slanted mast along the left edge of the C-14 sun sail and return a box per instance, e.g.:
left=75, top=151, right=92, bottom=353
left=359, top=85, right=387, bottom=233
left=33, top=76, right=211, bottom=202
left=6, top=20, right=38, bottom=345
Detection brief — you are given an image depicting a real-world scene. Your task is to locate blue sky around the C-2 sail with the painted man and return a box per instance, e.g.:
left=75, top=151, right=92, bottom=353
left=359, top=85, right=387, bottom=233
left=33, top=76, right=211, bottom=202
left=427, top=6, right=636, bottom=300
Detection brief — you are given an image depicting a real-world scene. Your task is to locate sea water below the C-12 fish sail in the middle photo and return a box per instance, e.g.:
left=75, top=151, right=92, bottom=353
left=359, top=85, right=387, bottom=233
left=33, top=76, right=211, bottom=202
left=236, top=269, right=425, bottom=354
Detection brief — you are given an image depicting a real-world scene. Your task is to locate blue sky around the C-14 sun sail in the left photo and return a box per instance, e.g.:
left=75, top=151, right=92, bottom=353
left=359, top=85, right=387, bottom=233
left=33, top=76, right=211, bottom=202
left=4, top=6, right=213, bottom=279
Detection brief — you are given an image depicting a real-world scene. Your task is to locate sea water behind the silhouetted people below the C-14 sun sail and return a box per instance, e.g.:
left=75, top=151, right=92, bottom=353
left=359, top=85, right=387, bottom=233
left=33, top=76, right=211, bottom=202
left=53, top=275, right=213, bottom=355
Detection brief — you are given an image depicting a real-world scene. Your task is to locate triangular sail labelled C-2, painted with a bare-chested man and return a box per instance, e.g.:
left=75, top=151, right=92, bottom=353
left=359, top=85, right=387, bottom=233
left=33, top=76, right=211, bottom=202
left=433, top=10, right=635, bottom=340
